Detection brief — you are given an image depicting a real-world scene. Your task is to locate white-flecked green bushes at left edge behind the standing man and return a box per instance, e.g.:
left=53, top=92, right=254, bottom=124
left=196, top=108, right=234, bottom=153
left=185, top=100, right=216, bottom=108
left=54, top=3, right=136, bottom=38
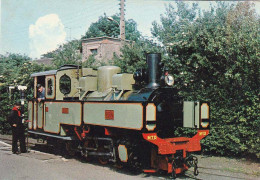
left=0, top=54, right=50, bottom=133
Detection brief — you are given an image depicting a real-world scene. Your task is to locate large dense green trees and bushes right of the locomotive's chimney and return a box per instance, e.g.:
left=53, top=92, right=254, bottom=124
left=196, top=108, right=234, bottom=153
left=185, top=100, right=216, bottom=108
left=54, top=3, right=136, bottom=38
left=152, top=2, right=260, bottom=157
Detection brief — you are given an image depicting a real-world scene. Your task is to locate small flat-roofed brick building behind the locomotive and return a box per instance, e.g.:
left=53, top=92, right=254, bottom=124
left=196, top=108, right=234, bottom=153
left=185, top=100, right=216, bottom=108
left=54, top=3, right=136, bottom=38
left=82, top=36, right=130, bottom=63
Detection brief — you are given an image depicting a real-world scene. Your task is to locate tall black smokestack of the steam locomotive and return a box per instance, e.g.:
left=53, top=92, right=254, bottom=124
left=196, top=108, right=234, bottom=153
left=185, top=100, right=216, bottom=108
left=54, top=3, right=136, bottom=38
left=146, top=53, right=161, bottom=88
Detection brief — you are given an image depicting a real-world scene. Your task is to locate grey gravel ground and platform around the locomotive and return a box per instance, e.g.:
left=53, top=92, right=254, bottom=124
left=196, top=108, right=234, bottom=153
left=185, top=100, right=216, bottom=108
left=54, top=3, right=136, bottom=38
left=0, top=135, right=260, bottom=180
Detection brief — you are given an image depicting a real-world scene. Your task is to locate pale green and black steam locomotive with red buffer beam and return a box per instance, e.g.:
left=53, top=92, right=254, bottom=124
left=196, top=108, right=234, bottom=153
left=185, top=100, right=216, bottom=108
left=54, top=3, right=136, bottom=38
left=28, top=54, right=210, bottom=176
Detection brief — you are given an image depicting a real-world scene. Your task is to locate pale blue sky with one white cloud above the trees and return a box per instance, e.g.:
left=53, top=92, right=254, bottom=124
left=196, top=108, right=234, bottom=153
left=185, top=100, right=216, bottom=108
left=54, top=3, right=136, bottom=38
left=0, top=0, right=260, bottom=59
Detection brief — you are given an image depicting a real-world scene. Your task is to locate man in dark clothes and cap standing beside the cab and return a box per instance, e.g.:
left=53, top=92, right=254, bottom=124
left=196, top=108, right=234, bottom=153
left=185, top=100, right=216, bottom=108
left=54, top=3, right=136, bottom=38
left=9, top=101, right=27, bottom=154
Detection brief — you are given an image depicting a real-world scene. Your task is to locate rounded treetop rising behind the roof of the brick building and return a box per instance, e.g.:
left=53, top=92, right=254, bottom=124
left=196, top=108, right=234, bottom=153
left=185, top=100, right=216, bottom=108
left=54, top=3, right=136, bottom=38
left=82, top=14, right=141, bottom=41
